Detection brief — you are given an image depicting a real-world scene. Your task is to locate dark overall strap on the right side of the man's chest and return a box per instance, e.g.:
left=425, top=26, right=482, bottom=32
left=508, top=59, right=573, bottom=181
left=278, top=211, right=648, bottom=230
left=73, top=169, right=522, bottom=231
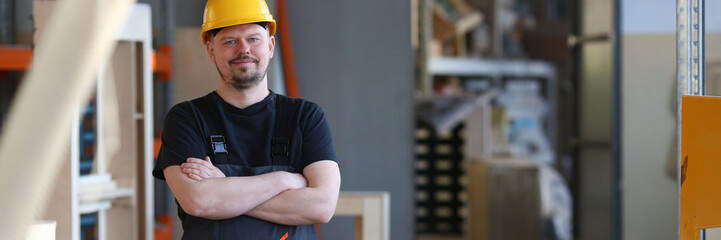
left=270, top=95, right=292, bottom=166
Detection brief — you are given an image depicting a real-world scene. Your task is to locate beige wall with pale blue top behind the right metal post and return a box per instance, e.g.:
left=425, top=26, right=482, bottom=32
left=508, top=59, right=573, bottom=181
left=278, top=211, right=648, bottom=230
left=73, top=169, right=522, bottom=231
left=621, top=0, right=721, bottom=239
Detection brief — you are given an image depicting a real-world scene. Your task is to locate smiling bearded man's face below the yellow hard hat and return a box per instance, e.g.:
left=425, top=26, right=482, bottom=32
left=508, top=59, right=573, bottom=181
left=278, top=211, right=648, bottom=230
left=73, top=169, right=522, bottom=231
left=210, top=23, right=275, bottom=90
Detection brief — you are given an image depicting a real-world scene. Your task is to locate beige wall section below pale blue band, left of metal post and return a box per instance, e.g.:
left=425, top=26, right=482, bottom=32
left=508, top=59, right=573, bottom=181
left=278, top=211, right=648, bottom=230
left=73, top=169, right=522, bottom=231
left=621, top=34, right=678, bottom=239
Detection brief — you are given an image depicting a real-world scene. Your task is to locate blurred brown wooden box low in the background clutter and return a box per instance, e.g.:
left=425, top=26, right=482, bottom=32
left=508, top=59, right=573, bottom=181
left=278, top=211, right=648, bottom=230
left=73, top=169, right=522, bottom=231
left=466, top=159, right=541, bottom=240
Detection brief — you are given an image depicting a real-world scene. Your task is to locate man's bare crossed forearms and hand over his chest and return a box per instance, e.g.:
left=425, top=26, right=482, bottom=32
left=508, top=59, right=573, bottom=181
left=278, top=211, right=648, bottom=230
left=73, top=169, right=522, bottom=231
left=163, top=157, right=340, bottom=225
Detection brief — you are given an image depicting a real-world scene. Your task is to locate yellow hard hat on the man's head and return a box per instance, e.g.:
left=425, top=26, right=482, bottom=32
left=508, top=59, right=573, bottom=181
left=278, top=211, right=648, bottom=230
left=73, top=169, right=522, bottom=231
left=200, top=0, right=275, bottom=44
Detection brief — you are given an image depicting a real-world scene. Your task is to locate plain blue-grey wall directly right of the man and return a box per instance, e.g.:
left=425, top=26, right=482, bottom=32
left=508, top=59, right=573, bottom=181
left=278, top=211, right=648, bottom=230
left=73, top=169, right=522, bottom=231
left=281, top=0, right=414, bottom=240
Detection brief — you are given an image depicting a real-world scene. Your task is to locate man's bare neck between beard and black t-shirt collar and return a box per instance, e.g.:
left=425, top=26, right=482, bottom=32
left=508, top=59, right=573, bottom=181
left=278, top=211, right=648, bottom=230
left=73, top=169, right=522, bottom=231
left=217, top=79, right=270, bottom=108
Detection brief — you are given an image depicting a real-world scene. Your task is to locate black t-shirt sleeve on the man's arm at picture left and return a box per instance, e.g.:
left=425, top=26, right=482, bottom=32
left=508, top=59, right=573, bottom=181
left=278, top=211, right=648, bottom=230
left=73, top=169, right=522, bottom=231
left=153, top=102, right=206, bottom=180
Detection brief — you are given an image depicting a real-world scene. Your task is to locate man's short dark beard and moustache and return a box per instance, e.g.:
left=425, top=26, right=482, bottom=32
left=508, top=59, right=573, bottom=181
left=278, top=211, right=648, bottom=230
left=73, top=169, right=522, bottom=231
left=215, top=55, right=268, bottom=90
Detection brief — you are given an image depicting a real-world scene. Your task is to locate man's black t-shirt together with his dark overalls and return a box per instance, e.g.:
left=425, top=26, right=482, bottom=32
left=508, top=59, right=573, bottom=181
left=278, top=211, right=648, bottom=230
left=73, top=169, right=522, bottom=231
left=153, top=92, right=337, bottom=239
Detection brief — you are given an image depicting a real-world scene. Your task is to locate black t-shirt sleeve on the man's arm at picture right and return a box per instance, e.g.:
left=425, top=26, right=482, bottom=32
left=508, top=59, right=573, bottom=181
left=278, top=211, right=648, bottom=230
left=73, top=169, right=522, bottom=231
left=301, top=103, right=338, bottom=169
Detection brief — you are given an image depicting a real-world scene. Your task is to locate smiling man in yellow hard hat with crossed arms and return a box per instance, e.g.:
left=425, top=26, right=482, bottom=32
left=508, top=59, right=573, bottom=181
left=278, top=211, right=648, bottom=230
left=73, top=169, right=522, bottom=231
left=153, top=0, right=340, bottom=240
